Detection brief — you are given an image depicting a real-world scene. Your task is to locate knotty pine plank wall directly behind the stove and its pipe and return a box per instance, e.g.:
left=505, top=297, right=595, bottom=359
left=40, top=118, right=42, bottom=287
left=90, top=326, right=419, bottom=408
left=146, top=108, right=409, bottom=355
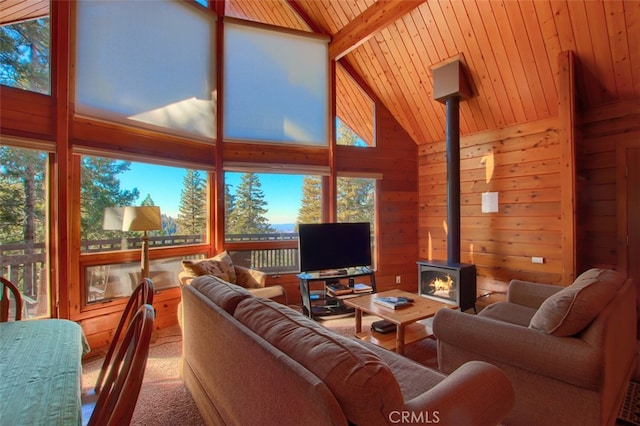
left=418, top=119, right=562, bottom=291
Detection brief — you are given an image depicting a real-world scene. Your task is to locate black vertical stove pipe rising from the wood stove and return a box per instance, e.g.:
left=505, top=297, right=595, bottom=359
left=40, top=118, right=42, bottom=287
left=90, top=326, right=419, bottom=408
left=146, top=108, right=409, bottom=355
left=446, top=96, right=460, bottom=264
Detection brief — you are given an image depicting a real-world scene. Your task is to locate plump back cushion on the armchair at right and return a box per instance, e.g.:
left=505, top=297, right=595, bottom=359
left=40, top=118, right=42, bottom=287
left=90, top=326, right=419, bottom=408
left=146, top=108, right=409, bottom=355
left=529, top=269, right=625, bottom=337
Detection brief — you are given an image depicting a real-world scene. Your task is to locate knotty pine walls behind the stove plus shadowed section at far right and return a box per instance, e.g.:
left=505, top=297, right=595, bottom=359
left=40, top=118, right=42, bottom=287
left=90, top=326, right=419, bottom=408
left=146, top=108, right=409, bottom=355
left=418, top=99, right=640, bottom=291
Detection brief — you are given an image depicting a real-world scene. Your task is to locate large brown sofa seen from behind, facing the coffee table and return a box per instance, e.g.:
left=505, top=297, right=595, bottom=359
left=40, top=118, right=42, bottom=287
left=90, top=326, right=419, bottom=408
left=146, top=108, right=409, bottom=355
left=181, top=276, right=513, bottom=426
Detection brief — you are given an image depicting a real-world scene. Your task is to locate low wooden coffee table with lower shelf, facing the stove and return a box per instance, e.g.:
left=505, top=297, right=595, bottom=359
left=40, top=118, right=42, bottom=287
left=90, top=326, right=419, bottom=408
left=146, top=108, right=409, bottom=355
left=343, top=290, right=457, bottom=354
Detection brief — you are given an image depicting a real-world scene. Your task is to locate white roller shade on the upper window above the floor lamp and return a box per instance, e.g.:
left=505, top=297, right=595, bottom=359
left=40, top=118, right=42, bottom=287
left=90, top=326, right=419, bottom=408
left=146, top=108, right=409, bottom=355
left=76, top=0, right=216, bottom=139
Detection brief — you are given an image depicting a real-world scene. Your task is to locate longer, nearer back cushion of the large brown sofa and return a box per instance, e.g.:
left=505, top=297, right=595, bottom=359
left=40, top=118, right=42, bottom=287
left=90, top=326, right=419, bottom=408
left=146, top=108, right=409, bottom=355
left=234, top=298, right=403, bottom=425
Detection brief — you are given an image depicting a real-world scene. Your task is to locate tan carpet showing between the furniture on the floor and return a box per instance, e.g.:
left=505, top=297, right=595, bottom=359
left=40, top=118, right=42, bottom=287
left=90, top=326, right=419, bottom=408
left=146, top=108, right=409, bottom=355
left=82, top=316, right=437, bottom=426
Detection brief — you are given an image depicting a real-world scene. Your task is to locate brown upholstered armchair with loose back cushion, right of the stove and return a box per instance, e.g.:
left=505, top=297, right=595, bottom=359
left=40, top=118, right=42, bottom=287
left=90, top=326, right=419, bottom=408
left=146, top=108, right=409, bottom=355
left=433, top=269, right=637, bottom=425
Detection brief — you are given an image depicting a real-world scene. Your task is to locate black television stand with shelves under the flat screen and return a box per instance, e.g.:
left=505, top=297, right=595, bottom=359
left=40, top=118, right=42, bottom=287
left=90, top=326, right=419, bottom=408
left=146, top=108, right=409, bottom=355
left=297, top=267, right=376, bottom=319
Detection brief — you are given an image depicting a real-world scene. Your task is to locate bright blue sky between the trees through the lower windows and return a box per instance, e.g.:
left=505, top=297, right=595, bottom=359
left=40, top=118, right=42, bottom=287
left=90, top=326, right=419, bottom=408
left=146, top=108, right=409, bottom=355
left=118, top=163, right=303, bottom=225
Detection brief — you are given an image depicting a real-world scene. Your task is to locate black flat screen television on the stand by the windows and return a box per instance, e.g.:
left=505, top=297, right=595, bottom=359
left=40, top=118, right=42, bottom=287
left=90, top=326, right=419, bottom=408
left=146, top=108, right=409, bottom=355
left=298, top=222, right=371, bottom=272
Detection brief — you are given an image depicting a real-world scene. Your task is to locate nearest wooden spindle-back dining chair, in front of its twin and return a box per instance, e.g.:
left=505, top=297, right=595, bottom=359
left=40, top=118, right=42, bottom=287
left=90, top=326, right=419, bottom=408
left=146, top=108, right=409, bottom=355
left=82, top=304, right=155, bottom=426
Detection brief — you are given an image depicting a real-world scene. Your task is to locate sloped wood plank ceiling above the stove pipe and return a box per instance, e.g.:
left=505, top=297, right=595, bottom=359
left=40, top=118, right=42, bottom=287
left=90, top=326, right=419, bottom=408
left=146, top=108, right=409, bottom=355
left=225, top=0, right=640, bottom=145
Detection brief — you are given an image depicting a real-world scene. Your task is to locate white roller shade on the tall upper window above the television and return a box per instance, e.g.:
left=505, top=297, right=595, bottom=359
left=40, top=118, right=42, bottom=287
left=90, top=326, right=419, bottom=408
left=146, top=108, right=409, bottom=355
left=224, top=20, right=329, bottom=146
